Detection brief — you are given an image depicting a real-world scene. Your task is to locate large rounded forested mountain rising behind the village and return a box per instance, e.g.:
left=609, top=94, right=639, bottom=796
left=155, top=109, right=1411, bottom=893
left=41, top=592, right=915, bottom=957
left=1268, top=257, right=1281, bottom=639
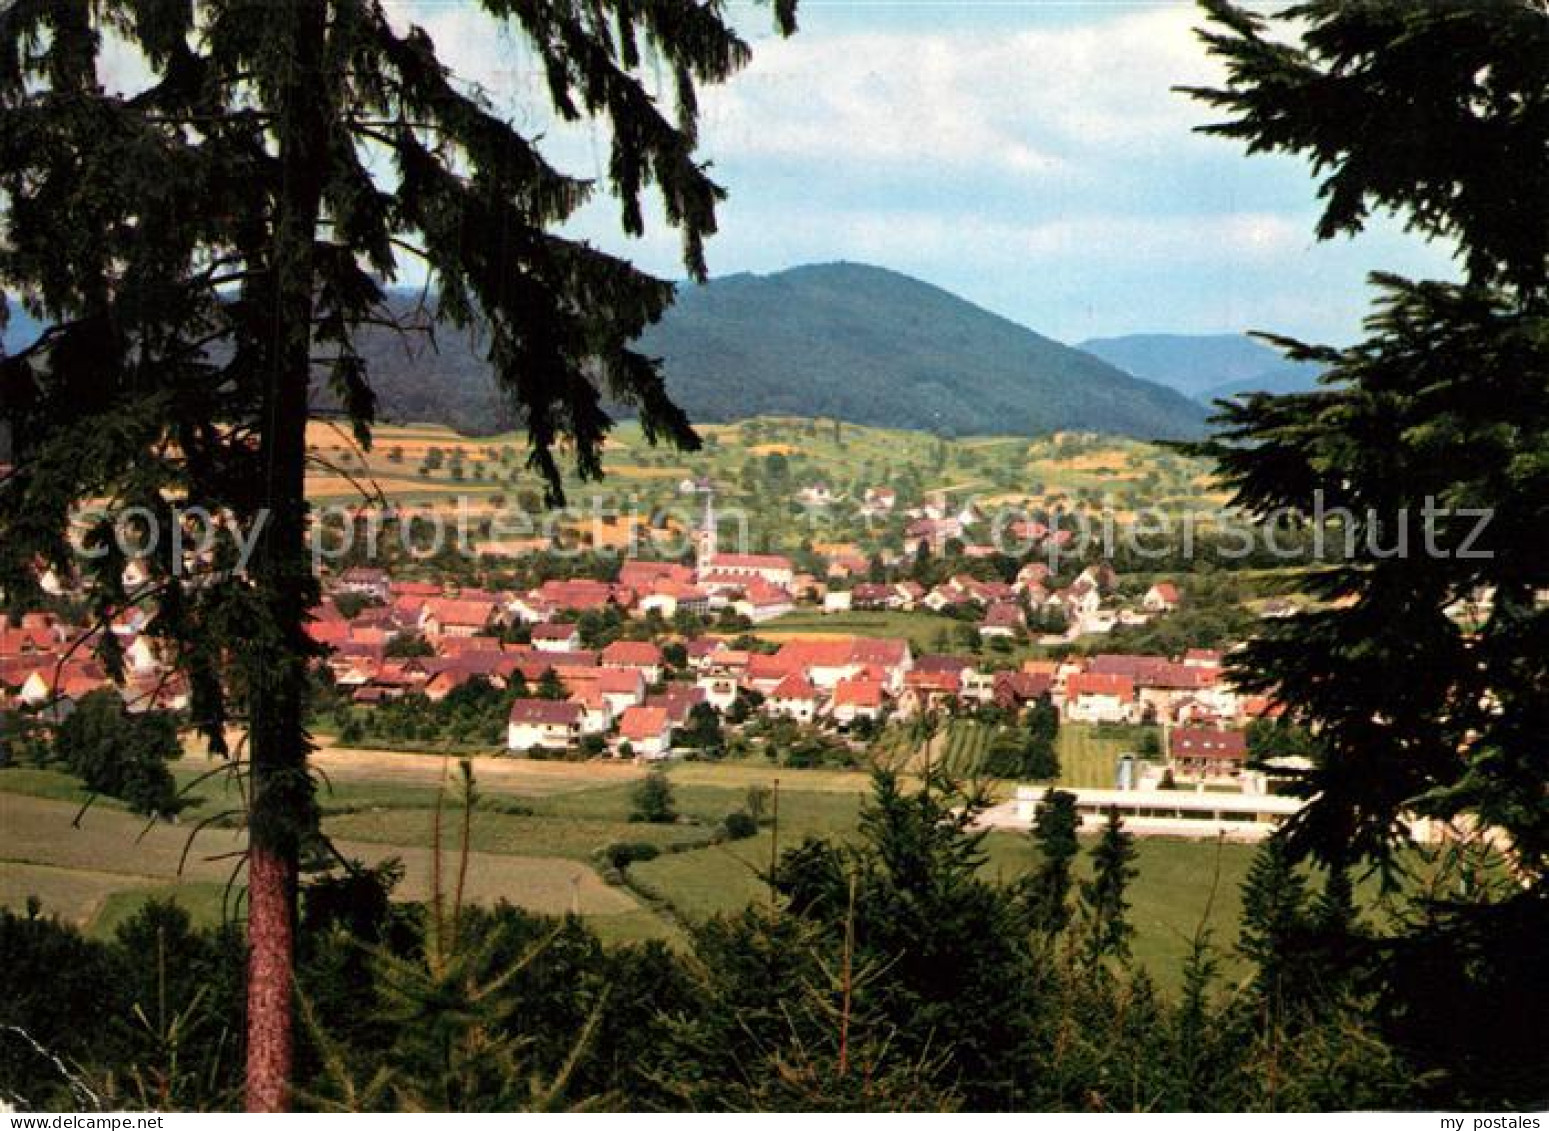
left=348, top=263, right=1207, bottom=438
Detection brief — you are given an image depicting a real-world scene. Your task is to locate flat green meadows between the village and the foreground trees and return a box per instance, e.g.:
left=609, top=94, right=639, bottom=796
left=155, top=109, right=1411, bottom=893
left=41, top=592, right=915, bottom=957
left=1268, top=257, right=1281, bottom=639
left=0, top=728, right=1270, bottom=985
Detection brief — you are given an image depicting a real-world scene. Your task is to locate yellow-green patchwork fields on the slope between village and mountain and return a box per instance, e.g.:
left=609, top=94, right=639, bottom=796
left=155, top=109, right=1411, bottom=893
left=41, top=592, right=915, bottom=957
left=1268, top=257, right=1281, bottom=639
left=308, top=417, right=1218, bottom=550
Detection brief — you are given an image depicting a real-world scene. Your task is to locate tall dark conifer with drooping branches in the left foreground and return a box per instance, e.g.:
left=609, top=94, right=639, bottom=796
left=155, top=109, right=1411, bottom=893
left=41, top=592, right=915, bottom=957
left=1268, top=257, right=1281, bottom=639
left=0, top=0, right=795, bottom=1109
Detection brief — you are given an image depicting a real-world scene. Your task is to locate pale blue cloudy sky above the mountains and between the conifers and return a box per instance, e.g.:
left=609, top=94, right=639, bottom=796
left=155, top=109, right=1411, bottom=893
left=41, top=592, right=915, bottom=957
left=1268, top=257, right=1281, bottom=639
left=93, top=0, right=1453, bottom=344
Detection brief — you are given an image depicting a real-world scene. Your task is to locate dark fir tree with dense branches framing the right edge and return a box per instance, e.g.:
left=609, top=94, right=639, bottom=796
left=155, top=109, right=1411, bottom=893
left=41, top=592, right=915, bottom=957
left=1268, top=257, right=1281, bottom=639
left=1191, top=0, right=1549, bottom=1102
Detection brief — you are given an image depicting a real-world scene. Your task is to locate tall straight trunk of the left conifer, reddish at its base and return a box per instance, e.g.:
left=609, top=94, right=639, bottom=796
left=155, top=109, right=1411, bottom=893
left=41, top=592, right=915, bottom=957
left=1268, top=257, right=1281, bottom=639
left=246, top=0, right=333, bottom=1111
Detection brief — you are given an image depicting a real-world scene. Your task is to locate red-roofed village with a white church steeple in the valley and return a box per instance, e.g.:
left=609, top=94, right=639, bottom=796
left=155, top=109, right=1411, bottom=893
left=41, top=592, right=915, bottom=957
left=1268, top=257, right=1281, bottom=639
left=0, top=488, right=1295, bottom=835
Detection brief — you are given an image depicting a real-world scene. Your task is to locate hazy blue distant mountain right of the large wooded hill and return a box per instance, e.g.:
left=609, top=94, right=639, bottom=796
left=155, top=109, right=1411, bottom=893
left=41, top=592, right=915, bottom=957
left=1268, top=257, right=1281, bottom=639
left=1077, top=333, right=1320, bottom=404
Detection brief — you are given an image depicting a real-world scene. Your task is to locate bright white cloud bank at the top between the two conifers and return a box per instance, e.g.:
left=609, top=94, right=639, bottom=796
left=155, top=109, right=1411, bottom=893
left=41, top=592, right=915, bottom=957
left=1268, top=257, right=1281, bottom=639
left=706, top=6, right=1214, bottom=178
